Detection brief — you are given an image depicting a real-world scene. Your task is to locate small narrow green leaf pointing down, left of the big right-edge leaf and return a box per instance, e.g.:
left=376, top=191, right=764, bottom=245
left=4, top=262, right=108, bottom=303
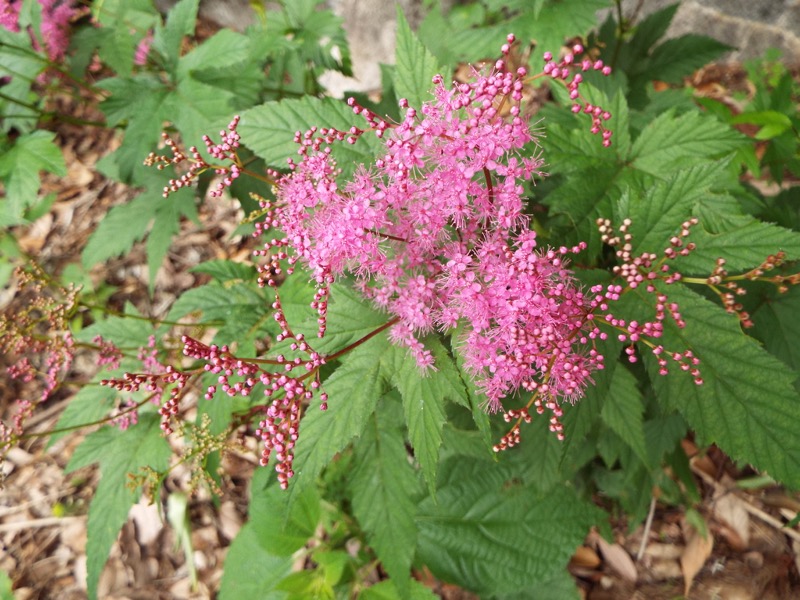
left=600, top=368, right=649, bottom=464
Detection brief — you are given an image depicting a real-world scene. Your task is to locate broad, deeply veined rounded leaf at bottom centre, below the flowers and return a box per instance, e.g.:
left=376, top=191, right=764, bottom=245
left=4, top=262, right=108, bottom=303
left=417, top=459, right=602, bottom=594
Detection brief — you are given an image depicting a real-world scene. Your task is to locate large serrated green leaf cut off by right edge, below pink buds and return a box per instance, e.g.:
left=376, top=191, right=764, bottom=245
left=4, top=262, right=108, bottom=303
left=646, top=285, right=800, bottom=487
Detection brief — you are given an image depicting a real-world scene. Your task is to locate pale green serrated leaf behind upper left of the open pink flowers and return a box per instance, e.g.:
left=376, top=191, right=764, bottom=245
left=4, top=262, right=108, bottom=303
left=239, top=96, right=380, bottom=177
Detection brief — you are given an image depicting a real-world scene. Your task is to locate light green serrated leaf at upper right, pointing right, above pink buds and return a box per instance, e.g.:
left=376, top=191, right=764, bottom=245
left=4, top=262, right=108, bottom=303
left=631, top=111, right=747, bottom=177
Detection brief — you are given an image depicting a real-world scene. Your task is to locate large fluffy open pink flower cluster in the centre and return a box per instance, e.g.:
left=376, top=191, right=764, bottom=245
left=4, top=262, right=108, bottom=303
left=257, top=36, right=608, bottom=422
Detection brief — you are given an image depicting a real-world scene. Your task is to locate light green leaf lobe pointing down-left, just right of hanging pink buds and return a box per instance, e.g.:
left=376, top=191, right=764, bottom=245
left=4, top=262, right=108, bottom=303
left=292, top=335, right=389, bottom=494
